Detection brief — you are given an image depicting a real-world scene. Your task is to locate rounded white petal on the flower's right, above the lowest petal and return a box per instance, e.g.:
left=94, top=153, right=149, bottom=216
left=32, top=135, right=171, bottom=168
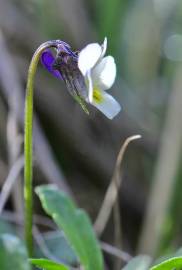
left=91, top=56, right=116, bottom=90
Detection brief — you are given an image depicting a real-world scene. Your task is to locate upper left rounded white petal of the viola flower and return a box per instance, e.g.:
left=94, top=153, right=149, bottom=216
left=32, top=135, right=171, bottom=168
left=78, top=43, right=103, bottom=76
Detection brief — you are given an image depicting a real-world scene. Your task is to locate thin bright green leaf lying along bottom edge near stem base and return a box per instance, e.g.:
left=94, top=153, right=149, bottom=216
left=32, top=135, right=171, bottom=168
left=29, top=259, right=69, bottom=270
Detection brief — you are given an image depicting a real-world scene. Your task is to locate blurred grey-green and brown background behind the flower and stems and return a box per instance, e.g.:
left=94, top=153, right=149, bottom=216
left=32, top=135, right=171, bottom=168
left=0, top=0, right=182, bottom=266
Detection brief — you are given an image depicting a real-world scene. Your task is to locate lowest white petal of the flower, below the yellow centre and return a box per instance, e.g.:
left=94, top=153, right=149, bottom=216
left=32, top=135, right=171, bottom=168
left=92, top=92, right=121, bottom=119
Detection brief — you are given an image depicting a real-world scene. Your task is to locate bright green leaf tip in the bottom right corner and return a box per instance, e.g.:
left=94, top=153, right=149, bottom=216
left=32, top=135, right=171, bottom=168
left=150, top=257, right=182, bottom=270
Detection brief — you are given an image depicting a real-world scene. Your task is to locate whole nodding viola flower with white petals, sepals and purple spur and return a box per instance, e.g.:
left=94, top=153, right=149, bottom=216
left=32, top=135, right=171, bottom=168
left=41, top=38, right=121, bottom=119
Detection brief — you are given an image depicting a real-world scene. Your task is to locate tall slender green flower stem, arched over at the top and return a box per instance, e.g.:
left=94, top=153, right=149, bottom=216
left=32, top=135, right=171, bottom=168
left=24, top=41, right=57, bottom=257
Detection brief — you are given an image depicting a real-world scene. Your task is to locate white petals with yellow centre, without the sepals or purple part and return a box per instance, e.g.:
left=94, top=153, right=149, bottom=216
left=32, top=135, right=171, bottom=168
left=78, top=38, right=121, bottom=119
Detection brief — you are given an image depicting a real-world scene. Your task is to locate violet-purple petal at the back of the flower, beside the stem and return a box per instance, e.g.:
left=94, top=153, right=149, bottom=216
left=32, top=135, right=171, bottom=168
left=41, top=50, right=62, bottom=79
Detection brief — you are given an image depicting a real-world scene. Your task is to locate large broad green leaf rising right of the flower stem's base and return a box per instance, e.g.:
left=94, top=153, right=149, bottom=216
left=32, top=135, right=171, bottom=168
left=36, top=185, right=103, bottom=270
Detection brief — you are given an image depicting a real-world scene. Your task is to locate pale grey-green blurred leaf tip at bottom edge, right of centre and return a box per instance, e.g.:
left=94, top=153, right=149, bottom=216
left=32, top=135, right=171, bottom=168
left=122, top=255, right=151, bottom=270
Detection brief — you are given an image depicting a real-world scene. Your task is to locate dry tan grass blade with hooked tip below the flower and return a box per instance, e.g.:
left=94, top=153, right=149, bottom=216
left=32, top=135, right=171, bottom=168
left=94, top=135, right=141, bottom=236
